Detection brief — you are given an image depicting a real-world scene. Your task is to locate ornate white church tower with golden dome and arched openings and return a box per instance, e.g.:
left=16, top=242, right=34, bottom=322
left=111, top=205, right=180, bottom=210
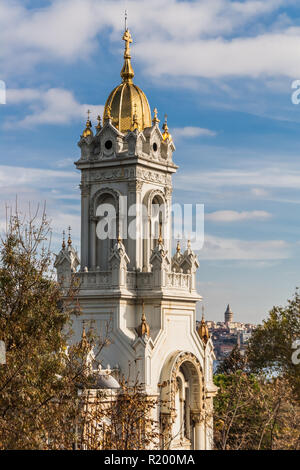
left=56, top=29, right=216, bottom=449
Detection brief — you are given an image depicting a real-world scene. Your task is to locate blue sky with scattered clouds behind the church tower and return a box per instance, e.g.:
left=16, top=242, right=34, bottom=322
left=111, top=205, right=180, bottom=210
left=0, top=0, right=300, bottom=322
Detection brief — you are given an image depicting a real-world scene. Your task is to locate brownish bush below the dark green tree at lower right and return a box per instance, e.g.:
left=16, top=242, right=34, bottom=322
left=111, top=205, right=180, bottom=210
left=214, top=371, right=300, bottom=450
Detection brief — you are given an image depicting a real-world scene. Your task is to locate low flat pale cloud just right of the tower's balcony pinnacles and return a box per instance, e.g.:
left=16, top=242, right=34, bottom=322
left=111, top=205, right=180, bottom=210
left=192, top=234, right=290, bottom=261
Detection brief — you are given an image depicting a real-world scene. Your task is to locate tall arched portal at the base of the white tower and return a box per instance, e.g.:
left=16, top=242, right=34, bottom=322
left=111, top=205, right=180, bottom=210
left=160, top=351, right=204, bottom=449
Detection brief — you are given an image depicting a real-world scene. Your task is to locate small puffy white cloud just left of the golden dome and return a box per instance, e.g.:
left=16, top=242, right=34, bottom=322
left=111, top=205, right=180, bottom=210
left=5, top=88, right=104, bottom=128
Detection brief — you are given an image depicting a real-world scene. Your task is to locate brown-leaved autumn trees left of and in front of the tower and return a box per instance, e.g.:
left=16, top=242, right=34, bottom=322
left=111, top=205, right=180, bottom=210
left=0, top=207, right=162, bottom=450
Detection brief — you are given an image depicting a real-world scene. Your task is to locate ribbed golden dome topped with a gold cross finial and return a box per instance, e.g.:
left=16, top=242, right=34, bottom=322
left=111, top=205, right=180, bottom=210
left=103, top=29, right=152, bottom=132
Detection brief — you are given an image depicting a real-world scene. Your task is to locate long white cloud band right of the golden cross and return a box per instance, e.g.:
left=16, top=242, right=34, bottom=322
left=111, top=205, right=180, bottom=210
left=137, top=27, right=300, bottom=78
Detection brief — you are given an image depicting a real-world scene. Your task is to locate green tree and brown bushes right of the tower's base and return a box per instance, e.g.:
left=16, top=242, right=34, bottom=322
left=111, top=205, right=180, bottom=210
left=214, top=292, right=300, bottom=450
